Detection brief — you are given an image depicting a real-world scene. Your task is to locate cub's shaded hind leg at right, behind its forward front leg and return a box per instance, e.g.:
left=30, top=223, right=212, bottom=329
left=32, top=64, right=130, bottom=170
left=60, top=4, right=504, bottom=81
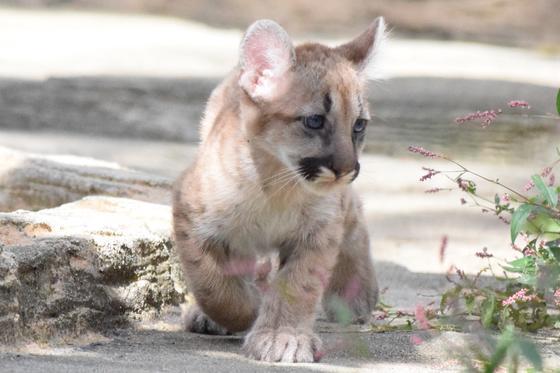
left=323, top=219, right=379, bottom=323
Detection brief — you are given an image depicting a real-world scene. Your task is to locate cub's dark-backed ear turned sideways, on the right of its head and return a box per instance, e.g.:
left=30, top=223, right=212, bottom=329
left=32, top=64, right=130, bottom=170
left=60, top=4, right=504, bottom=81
left=335, top=17, right=387, bottom=79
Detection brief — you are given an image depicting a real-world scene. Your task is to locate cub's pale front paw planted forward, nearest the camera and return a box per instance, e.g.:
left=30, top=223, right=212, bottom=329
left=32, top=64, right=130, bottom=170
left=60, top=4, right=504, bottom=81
left=243, top=327, right=321, bottom=363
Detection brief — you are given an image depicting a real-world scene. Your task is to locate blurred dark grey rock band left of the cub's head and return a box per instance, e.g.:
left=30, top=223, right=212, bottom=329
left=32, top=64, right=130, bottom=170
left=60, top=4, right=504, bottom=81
left=0, top=77, right=212, bottom=141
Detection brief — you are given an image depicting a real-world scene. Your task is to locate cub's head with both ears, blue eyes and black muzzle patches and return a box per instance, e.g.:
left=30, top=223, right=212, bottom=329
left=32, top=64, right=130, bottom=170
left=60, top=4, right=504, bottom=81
left=239, top=18, right=385, bottom=191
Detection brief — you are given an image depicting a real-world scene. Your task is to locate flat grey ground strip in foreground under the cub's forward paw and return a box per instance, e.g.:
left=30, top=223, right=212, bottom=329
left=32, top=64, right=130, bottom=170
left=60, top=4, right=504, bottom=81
left=0, top=327, right=480, bottom=373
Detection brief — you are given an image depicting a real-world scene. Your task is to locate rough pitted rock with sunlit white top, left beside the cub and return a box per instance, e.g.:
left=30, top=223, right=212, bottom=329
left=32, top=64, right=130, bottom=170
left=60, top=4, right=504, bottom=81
left=0, top=197, right=186, bottom=343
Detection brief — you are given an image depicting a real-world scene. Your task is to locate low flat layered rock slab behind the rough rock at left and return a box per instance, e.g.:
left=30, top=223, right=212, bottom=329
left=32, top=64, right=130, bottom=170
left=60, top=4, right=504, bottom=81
left=0, top=147, right=171, bottom=211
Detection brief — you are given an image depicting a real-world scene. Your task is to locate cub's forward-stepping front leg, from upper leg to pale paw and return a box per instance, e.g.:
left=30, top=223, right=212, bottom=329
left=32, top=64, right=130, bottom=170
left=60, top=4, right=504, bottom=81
left=243, top=238, right=338, bottom=362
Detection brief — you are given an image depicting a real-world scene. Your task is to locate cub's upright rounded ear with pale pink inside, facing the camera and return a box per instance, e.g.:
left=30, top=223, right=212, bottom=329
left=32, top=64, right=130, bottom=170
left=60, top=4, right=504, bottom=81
left=239, top=19, right=296, bottom=101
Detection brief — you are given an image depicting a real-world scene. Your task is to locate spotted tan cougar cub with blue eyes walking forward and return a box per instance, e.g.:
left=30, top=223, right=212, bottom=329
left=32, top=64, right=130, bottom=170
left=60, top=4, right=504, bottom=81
left=173, top=18, right=385, bottom=362
